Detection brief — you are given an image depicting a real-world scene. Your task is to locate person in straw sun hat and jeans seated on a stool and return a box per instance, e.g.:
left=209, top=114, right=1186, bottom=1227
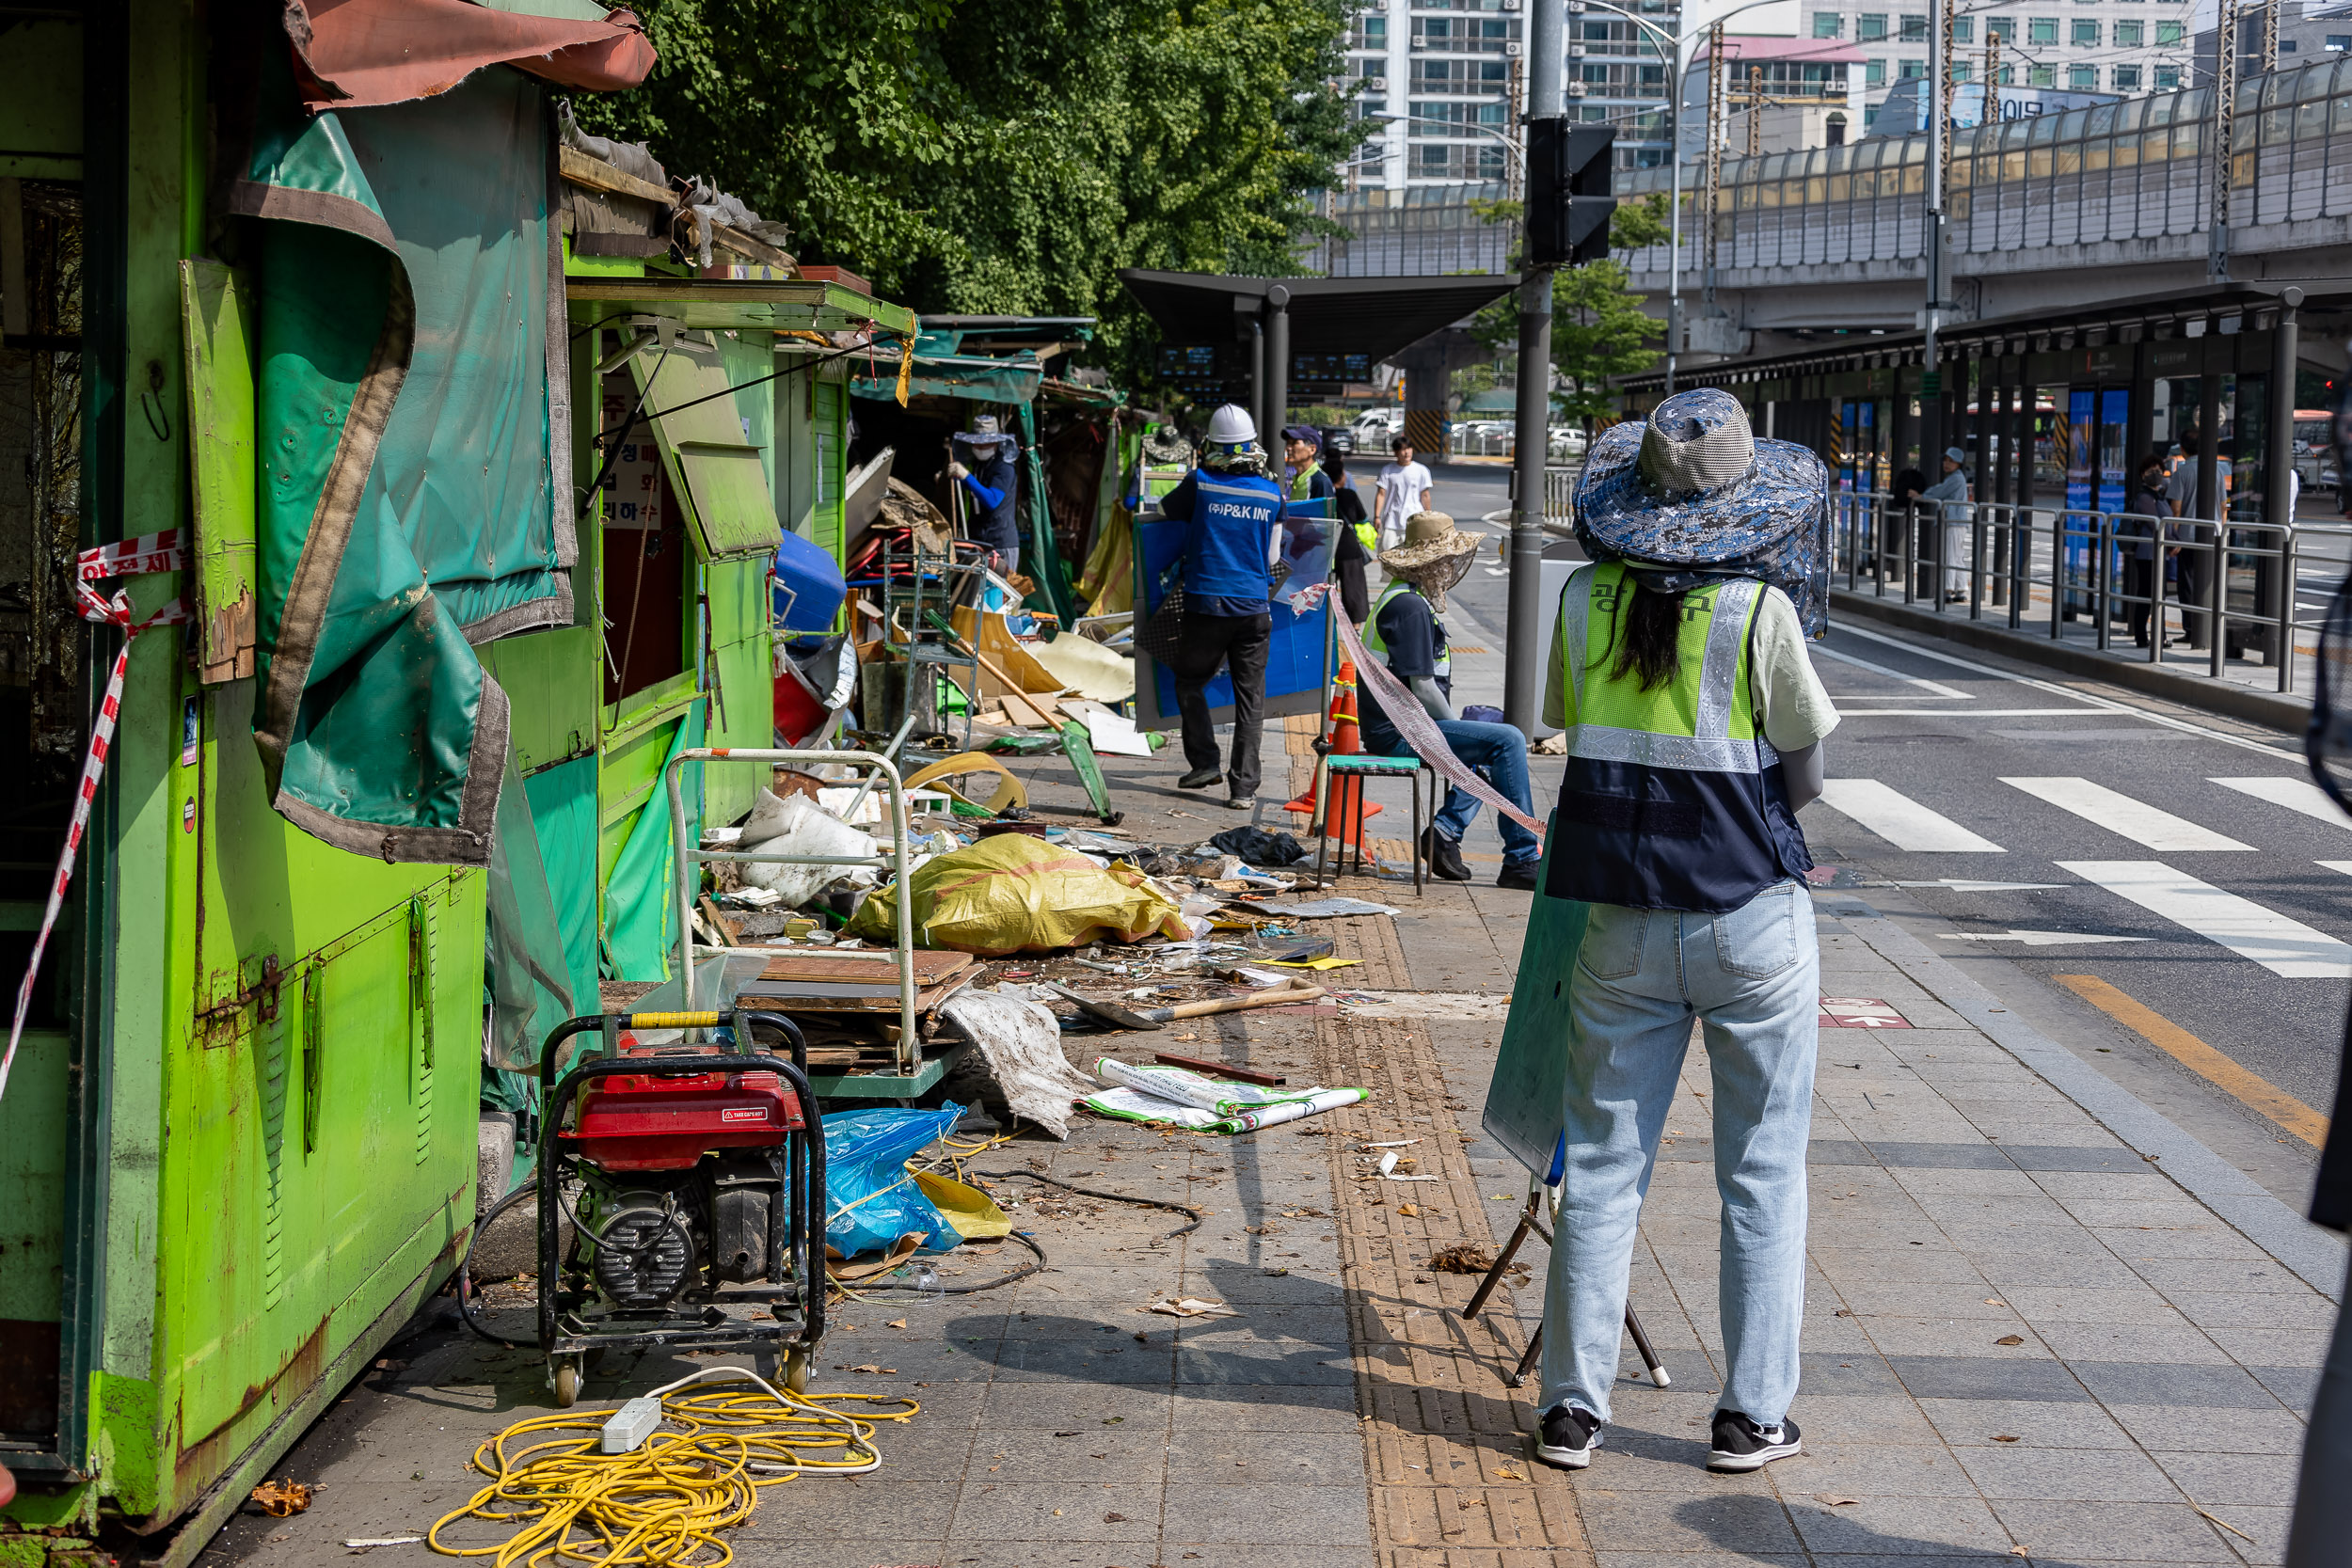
left=1358, top=513, right=1543, bottom=891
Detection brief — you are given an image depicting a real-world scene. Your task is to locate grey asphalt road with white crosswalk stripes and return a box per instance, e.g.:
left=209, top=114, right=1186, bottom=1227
left=1367, top=463, right=2352, bottom=1132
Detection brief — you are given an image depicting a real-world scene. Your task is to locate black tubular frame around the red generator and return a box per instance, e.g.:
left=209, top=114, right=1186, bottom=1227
left=536, top=1008, right=831, bottom=1354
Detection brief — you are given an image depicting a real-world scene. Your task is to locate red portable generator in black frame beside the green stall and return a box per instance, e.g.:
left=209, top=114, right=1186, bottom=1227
left=539, top=1011, right=826, bottom=1406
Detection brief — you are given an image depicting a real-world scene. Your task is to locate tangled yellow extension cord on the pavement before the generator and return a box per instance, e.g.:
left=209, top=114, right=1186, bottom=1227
left=426, top=1366, right=922, bottom=1568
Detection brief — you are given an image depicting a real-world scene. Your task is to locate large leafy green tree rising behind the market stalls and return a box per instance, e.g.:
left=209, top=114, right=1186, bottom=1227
left=560, top=0, right=1355, bottom=376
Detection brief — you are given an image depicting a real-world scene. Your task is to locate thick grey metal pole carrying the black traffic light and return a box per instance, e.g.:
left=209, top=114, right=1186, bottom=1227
left=1503, top=0, right=1566, bottom=738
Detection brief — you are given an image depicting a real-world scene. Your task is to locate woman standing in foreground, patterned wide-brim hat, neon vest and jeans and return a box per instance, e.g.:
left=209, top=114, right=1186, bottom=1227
left=1536, top=388, right=1837, bottom=1472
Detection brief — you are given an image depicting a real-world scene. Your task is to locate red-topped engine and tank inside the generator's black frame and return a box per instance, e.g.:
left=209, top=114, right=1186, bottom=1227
left=564, top=1039, right=807, bottom=1314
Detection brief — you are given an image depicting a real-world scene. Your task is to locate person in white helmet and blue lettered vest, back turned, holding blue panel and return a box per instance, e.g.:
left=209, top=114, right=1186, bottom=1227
left=1160, top=402, right=1284, bottom=811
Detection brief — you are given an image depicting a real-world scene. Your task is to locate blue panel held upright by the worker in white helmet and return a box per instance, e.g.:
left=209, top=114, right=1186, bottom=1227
left=1136, top=500, right=1339, bottom=729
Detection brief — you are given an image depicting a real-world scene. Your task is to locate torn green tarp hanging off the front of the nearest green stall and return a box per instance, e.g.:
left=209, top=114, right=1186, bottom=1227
left=230, top=52, right=577, bottom=865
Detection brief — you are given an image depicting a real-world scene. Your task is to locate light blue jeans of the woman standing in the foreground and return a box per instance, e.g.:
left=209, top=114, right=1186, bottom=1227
left=1543, top=881, right=1820, bottom=1427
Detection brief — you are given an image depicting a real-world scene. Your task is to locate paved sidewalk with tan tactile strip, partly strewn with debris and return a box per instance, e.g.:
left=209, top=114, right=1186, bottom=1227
left=205, top=714, right=2343, bottom=1568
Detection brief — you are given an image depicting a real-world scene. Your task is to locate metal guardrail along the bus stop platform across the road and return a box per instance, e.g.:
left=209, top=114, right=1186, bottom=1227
left=1830, top=494, right=2352, bottom=693
